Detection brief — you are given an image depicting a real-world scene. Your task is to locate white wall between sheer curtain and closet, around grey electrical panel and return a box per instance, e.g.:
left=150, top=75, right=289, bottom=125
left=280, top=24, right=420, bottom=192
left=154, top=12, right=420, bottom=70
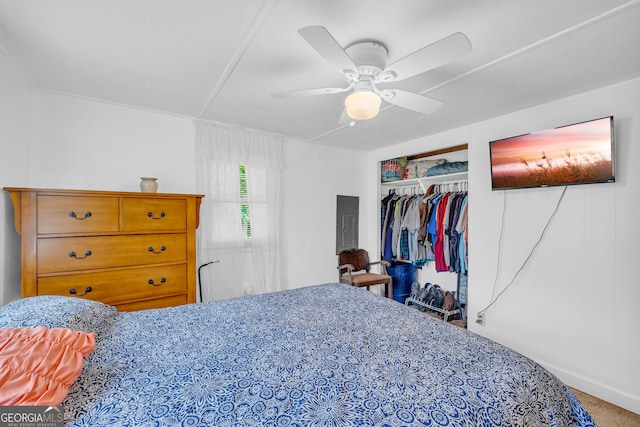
left=281, top=140, right=367, bottom=288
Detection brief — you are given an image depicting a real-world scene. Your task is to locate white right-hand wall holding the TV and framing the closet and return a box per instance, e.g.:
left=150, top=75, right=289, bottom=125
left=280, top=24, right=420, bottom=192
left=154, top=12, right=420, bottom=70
left=367, top=79, right=640, bottom=413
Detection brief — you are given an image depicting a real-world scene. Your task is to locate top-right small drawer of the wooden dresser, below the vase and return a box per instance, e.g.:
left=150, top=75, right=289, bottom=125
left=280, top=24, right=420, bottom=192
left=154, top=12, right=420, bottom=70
left=122, top=197, right=187, bottom=231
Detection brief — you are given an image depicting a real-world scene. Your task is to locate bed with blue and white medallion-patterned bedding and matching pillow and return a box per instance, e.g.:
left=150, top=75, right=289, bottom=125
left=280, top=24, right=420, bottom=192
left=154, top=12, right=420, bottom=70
left=0, top=284, right=595, bottom=427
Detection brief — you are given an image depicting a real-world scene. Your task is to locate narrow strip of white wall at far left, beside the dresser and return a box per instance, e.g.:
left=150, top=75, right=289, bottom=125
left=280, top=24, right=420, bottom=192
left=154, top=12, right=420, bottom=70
left=0, top=51, right=32, bottom=304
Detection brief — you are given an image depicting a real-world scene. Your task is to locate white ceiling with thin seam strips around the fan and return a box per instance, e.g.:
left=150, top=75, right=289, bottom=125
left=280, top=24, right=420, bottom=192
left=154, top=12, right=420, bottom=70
left=0, top=0, right=640, bottom=150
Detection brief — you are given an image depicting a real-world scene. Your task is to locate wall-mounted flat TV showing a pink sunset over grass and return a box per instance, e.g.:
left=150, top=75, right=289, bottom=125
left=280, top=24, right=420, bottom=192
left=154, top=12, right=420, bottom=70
left=489, top=116, right=615, bottom=190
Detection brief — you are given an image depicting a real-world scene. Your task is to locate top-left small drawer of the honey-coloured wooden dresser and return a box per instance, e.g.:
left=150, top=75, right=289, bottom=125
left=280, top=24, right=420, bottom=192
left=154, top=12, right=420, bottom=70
left=37, top=196, right=118, bottom=234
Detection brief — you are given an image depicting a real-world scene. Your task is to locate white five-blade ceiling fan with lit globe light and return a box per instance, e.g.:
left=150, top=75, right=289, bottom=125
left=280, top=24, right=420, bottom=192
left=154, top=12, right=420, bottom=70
left=272, top=25, right=471, bottom=124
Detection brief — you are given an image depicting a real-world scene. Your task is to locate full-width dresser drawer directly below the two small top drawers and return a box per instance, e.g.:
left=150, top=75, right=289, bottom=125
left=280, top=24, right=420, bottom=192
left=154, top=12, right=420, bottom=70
left=37, top=234, right=187, bottom=275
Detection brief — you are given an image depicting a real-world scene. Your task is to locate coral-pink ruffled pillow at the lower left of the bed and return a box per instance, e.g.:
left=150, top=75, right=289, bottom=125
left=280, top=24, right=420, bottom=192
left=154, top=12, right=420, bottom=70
left=0, top=326, right=96, bottom=406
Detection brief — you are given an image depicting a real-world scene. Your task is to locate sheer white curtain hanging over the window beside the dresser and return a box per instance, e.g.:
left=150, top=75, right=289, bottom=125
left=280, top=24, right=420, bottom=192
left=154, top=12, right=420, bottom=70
left=196, top=122, right=283, bottom=301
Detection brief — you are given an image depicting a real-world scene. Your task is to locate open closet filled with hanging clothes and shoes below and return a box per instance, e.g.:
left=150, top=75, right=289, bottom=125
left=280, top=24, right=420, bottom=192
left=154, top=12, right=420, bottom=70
left=378, top=144, right=469, bottom=325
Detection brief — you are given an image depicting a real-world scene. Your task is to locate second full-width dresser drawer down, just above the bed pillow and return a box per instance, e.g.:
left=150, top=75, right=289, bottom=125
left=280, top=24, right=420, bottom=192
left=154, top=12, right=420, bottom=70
left=38, top=264, right=187, bottom=304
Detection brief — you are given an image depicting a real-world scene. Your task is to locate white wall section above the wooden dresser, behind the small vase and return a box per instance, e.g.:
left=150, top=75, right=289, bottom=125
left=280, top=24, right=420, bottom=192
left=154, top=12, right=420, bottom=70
left=30, top=92, right=196, bottom=193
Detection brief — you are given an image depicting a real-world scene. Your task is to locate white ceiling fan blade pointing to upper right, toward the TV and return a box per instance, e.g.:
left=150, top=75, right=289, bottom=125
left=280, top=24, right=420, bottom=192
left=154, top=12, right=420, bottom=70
left=380, top=33, right=472, bottom=81
